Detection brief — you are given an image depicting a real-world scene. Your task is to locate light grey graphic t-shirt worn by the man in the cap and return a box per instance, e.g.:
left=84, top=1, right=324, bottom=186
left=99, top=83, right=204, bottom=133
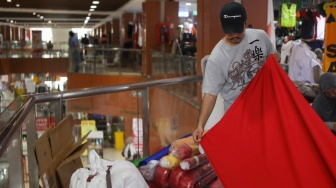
left=202, top=29, right=276, bottom=111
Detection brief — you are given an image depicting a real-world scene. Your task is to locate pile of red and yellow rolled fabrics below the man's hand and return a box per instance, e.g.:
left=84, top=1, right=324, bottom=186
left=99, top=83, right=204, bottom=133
left=148, top=136, right=220, bottom=188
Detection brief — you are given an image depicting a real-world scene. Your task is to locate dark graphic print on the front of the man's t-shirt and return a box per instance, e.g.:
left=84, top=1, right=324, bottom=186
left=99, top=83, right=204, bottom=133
left=228, top=45, right=265, bottom=91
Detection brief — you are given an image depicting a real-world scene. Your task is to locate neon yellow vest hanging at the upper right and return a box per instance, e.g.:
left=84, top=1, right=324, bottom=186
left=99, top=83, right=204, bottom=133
left=281, top=3, right=296, bottom=27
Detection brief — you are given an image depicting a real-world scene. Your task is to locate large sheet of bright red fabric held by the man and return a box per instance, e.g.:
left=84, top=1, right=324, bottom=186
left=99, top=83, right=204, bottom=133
left=200, top=55, right=336, bottom=188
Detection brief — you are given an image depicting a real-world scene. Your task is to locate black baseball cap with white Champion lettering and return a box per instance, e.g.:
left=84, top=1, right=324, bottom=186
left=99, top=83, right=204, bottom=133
left=219, top=2, right=246, bottom=34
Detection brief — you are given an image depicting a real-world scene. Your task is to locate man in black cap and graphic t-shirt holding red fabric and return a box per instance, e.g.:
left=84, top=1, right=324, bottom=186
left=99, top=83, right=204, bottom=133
left=193, top=2, right=280, bottom=143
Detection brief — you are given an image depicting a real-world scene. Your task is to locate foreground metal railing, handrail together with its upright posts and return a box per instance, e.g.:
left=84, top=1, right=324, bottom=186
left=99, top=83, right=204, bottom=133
left=0, top=76, right=202, bottom=188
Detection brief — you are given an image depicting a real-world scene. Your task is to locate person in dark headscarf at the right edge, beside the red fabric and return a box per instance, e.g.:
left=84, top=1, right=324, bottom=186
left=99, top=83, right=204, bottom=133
left=312, top=72, right=336, bottom=135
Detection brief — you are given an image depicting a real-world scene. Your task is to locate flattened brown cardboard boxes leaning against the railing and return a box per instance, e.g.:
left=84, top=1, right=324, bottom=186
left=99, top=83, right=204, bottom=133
left=34, top=115, right=89, bottom=188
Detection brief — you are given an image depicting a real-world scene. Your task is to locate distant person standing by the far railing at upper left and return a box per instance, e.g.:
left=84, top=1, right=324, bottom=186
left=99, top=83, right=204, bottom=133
left=68, top=31, right=80, bottom=72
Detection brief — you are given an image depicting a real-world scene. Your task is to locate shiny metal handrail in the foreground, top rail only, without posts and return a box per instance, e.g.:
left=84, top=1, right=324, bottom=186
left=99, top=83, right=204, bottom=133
left=0, top=76, right=203, bottom=156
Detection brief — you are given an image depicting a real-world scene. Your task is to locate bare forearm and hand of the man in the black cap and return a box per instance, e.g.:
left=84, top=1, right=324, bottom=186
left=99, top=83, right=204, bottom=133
left=193, top=93, right=217, bottom=143
